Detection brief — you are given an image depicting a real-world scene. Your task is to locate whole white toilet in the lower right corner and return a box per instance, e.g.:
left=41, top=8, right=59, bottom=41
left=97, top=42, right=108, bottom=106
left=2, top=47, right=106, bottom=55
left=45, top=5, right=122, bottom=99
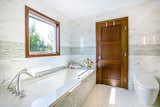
left=134, top=72, right=159, bottom=105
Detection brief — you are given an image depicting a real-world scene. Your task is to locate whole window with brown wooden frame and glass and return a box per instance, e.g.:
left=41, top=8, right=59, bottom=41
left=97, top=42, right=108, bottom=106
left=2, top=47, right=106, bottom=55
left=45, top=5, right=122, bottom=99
left=25, top=6, right=60, bottom=57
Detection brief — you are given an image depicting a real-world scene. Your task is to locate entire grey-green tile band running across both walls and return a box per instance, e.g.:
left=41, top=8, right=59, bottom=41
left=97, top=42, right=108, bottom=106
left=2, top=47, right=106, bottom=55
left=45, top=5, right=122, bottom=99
left=0, top=41, right=160, bottom=56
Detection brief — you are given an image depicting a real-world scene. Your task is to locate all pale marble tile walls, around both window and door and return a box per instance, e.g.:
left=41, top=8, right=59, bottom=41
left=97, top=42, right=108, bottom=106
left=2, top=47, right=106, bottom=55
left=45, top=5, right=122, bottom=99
left=0, top=0, right=160, bottom=89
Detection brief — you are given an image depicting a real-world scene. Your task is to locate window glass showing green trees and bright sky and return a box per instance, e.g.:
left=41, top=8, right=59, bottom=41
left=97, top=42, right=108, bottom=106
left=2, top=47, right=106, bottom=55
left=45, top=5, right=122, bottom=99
left=29, top=16, right=56, bottom=54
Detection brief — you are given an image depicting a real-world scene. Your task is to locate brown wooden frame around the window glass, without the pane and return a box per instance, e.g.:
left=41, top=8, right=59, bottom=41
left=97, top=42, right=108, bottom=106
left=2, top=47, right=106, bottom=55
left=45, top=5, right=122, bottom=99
left=25, top=6, right=60, bottom=58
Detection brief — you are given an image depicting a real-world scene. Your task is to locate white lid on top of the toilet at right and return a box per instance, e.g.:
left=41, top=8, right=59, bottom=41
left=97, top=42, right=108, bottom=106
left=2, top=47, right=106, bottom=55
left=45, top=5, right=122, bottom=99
left=136, top=75, right=159, bottom=90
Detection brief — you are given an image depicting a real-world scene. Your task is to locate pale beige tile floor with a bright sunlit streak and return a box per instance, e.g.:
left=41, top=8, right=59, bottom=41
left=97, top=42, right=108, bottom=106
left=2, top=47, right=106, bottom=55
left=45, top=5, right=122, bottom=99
left=83, top=84, right=160, bottom=107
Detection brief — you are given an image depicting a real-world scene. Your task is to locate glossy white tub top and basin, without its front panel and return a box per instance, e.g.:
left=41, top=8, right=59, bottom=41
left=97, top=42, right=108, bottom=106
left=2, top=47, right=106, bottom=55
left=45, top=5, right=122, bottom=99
left=0, top=68, right=95, bottom=107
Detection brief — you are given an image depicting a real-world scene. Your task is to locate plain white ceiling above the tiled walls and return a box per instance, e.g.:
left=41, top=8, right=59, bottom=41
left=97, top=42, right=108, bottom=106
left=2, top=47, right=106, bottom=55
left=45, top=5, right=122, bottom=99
left=44, top=0, right=146, bottom=19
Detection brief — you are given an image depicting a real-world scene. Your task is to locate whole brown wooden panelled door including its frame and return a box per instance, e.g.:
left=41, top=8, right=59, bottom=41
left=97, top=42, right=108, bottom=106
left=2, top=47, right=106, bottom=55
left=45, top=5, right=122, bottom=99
left=96, top=17, right=128, bottom=88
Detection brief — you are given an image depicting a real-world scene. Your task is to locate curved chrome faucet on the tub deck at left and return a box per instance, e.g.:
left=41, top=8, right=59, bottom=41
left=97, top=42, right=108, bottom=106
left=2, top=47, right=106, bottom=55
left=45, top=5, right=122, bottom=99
left=8, top=68, right=33, bottom=97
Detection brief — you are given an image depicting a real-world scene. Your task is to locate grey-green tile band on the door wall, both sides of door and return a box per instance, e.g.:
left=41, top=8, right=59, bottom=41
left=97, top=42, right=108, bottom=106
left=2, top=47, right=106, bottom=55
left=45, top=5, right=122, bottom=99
left=71, top=44, right=160, bottom=56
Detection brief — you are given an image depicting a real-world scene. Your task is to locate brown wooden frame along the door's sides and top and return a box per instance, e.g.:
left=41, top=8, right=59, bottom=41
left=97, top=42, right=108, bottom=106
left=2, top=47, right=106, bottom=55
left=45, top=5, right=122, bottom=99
left=96, top=17, right=128, bottom=89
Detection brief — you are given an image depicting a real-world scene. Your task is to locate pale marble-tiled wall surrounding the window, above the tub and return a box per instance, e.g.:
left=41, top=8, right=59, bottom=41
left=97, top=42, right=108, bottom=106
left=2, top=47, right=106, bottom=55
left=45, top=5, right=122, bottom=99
left=0, top=0, right=72, bottom=83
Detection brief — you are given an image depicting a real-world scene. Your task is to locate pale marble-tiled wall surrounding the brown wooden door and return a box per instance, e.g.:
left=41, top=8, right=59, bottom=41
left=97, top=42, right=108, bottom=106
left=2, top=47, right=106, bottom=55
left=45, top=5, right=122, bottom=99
left=71, top=0, right=160, bottom=89
